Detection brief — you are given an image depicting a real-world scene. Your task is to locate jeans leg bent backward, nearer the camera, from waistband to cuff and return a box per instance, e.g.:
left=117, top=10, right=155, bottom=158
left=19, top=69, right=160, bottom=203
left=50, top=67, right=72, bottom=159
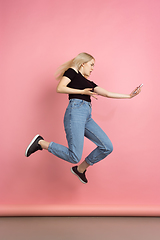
left=48, top=99, right=87, bottom=163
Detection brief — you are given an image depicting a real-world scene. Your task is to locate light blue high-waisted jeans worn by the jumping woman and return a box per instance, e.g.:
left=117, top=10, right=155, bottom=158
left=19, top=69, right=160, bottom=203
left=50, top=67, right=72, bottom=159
left=48, top=99, right=113, bottom=165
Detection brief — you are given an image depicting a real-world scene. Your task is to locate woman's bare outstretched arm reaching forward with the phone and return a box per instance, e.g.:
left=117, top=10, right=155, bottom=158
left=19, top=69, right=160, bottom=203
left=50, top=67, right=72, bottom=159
left=94, top=86, right=141, bottom=99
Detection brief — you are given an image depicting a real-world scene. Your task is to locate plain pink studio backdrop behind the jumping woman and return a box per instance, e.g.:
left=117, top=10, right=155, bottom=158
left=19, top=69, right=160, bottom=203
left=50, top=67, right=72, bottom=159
left=0, top=0, right=160, bottom=215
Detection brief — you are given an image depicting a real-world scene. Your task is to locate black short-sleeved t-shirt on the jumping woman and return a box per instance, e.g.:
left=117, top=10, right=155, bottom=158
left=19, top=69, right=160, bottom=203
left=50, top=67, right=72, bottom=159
left=63, top=68, right=97, bottom=102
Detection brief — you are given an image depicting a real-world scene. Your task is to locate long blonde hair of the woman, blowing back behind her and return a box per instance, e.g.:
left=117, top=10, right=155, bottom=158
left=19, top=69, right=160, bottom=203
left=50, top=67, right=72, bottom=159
left=55, top=52, right=94, bottom=80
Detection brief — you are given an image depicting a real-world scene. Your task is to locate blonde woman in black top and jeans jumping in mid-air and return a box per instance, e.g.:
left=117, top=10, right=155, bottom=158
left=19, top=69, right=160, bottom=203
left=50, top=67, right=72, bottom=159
left=25, top=53, right=141, bottom=183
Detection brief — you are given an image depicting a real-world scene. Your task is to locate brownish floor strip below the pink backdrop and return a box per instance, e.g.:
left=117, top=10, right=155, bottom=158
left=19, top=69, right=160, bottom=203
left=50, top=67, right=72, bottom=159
left=0, top=217, right=160, bottom=240
